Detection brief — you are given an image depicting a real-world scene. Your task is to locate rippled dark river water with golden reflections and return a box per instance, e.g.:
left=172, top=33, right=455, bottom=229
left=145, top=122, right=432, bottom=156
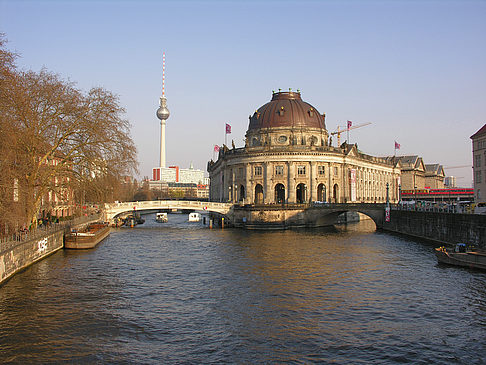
left=0, top=214, right=486, bottom=364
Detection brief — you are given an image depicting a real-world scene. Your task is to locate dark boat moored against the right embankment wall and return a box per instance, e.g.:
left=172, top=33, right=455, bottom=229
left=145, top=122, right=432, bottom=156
left=435, top=243, right=486, bottom=270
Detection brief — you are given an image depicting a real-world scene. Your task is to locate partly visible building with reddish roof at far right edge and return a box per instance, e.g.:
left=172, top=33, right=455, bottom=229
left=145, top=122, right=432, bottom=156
left=470, top=124, right=486, bottom=203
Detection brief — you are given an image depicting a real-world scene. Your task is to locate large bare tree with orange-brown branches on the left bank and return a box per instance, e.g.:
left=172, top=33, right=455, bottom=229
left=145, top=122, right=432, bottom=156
left=0, top=35, right=137, bottom=229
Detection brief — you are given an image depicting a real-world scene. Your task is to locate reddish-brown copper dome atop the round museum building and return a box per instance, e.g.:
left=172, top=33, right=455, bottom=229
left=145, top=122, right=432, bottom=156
left=248, top=91, right=326, bottom=131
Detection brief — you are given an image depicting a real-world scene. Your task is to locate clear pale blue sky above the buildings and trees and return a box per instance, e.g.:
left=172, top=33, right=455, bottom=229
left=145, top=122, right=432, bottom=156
left=0, top=0, right=486, bottom=187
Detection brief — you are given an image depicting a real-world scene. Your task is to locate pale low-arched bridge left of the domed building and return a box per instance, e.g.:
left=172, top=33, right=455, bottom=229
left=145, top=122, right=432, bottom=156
left=105, top=200, right=233, bottom=221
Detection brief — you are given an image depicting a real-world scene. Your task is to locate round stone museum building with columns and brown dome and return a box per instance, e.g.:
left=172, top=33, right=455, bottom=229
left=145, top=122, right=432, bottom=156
left=208, top=91, right=400, bottom=204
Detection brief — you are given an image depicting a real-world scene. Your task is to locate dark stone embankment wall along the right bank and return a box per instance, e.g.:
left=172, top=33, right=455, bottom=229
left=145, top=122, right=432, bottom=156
left=383, top=210, right=486, bottom=248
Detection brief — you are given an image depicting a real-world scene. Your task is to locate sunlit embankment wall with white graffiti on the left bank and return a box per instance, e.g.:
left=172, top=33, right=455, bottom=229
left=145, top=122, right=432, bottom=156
left=0, top=230, right=64, bottom=285
